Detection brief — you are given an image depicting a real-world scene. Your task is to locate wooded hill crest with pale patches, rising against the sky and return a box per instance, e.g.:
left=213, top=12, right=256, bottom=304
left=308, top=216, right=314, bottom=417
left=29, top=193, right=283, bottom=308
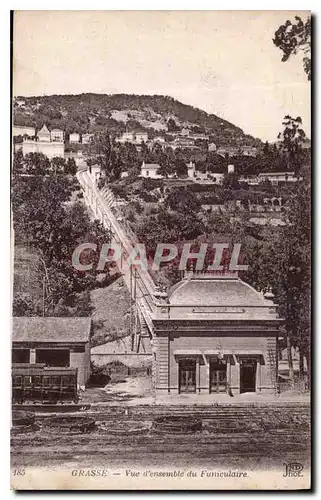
left=13, top=94, right=261, bottom=145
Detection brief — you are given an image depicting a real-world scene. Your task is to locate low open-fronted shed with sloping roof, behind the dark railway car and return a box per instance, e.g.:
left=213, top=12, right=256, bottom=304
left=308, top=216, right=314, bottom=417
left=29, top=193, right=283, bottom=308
left=12, top=317, right=92, bottom=388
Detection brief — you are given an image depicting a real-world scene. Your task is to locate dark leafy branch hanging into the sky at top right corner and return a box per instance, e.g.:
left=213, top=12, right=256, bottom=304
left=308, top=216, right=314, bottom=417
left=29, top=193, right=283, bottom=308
left=273, top=16, right=311, bottom=80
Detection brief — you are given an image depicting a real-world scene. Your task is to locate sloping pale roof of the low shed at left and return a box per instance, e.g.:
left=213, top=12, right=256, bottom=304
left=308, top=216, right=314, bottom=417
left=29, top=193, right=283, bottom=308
left=12, top=317, right=91, bottom=343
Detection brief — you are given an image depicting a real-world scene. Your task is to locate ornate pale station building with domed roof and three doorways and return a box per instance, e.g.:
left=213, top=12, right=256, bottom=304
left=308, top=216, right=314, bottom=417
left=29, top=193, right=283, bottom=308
left=152, top=274, right=282, bottom=396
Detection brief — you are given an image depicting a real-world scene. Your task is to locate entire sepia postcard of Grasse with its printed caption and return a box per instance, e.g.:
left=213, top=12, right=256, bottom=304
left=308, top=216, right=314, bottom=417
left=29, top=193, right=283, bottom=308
left=10, top=10, right=313, bottom=491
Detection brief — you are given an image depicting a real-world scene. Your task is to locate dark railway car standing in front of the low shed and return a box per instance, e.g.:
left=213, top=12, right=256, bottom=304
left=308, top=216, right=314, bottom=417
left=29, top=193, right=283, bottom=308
left=12, top=363, right=79, bottom=404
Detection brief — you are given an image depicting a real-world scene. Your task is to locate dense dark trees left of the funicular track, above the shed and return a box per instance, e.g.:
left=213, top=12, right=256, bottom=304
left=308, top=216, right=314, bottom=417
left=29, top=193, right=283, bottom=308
left=12, top=154, right=110, bottom=316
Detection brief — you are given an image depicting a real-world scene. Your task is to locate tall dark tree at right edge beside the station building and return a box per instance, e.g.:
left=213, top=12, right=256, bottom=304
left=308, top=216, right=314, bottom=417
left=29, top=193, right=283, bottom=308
left=241, top=183, right=311, bottom=386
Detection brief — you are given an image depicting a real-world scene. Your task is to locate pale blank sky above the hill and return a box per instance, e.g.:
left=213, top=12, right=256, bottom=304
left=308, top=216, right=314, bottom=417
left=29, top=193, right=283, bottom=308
left=13, top=11, right=310, bottom=141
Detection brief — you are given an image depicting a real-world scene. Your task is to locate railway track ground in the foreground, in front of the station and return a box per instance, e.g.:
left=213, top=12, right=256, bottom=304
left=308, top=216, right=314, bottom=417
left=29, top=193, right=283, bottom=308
left=12, top=404, right=310, bottom=470
